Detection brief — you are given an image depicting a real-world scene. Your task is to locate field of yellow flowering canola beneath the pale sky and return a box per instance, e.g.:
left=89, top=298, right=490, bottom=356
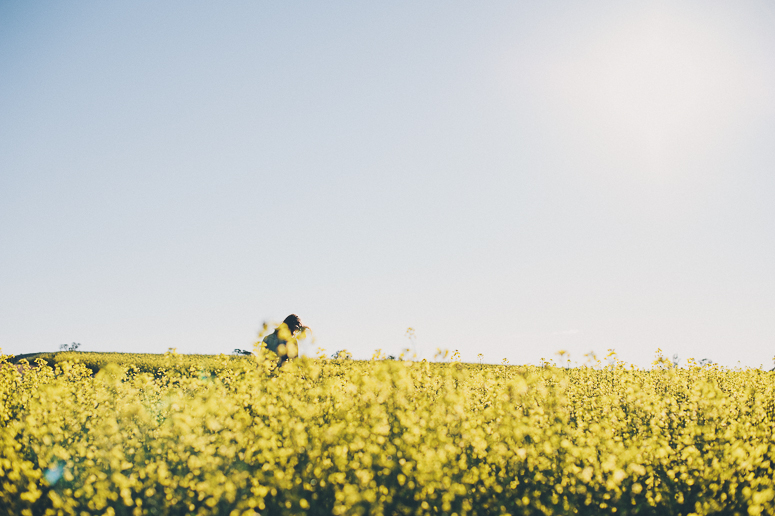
left=0, top=353, right=775, bottom=516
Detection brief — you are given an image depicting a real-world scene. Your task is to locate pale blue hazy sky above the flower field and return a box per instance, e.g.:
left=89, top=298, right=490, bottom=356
left=0, top=0, right=775, bottom=368
